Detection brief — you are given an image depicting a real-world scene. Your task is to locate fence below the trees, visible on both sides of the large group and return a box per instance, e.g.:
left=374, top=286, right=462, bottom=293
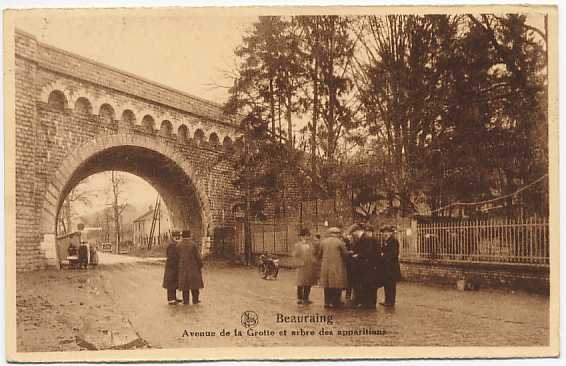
left=235, top=218, right=550, bottom=266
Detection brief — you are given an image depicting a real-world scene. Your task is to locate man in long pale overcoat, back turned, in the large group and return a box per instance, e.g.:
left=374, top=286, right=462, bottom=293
left=320, top=228, right=348, bottom=308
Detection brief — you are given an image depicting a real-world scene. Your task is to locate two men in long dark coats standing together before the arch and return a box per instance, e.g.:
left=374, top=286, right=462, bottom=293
left=163, top=230, right=204, bottom=305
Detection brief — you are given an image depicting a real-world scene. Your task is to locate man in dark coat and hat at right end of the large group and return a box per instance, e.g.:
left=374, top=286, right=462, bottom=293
left=380, top=226, right=401, bottom=306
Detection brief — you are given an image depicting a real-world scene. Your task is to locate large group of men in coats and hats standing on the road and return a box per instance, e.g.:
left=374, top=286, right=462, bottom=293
left=294, top=224, right=401, bottom=309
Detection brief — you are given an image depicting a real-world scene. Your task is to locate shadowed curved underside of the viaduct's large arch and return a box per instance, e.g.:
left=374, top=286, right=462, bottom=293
left=52, top=145, right=208, bottom=246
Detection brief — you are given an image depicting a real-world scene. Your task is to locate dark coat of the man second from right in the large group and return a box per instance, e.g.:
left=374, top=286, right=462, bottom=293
left=357, top=235, right=381, bottom=288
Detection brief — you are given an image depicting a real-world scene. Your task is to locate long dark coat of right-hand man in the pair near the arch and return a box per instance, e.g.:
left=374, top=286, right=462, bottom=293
left=177, top=238, right=204, bottom=291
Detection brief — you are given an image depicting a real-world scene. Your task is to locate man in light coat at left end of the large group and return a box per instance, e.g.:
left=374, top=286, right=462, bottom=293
left=293, top=229, right=318, bottom=305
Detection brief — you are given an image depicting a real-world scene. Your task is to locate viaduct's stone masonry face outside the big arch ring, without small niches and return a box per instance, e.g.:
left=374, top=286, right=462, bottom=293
left=15, top=31, right=242, bottom=271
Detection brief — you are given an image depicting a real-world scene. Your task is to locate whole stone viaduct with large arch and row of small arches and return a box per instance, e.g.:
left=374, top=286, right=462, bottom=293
left=15, top=31, right=244, bottom=271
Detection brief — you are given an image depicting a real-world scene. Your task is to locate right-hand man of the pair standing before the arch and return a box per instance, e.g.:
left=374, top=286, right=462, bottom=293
left=177, top=230, right=204, bottom=305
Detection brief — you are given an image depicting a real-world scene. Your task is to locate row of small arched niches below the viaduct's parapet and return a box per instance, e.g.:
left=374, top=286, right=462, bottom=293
left=47, top=90, right=237, bottom=149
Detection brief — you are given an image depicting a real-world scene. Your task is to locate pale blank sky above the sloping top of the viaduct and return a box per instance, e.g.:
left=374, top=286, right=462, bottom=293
left=16, top=10, right=256, bottom=103
